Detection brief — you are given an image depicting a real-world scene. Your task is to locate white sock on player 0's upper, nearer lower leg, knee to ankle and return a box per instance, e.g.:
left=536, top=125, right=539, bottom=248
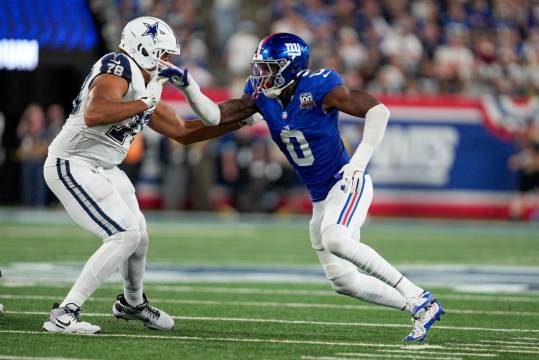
left=322, top=225, right=402, bottom=287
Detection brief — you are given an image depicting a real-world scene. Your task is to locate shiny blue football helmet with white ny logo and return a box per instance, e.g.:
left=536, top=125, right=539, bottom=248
left=249, top=33, right=310, bottom=99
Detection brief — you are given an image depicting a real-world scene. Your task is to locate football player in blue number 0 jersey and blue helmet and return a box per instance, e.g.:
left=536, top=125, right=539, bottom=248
left=160, top=33, right=444, bottom=341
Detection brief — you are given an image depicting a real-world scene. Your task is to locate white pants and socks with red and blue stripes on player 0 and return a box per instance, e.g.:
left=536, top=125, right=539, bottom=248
left=309, top=174, right=416, bottom=309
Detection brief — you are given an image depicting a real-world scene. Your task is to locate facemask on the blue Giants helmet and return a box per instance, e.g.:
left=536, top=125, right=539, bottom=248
left=249, top=58, right=294, bottom=99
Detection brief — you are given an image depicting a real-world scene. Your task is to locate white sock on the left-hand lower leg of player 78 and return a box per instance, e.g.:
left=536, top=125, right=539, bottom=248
left=60, top=229, right=140, bottom=307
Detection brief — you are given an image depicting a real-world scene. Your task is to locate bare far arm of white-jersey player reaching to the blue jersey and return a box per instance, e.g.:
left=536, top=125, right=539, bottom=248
left=148, top=103, right=247, bottom=145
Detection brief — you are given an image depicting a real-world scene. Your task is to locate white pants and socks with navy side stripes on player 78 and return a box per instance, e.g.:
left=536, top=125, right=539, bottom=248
left=44, top=156, right=148, bottom=306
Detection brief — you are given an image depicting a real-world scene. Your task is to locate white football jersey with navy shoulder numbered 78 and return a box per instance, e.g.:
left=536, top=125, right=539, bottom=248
left=49, top=53, right=151, bottom=167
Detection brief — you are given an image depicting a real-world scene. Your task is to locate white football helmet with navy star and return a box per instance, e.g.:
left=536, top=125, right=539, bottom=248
left=119, top=16, right=180, bottom=74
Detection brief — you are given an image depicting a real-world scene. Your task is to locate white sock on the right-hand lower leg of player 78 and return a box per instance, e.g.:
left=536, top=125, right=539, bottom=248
left=120, top=231, right=149, bottom=306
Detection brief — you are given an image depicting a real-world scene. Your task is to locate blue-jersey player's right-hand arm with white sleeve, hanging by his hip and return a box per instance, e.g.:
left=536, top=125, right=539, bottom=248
left=323, top=85, right=389, bottom=192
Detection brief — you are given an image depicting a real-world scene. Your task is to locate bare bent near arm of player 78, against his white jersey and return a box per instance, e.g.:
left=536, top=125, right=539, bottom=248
left=84, top=74, right=157, bottom=127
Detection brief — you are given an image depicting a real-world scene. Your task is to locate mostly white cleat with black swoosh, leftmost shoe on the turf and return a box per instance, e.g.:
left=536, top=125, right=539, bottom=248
left=43, top=303, right=101, bottom=334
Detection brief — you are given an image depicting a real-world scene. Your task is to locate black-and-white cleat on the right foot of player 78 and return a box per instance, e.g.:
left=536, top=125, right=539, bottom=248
left=112, top=294, right=174, bottom=330
